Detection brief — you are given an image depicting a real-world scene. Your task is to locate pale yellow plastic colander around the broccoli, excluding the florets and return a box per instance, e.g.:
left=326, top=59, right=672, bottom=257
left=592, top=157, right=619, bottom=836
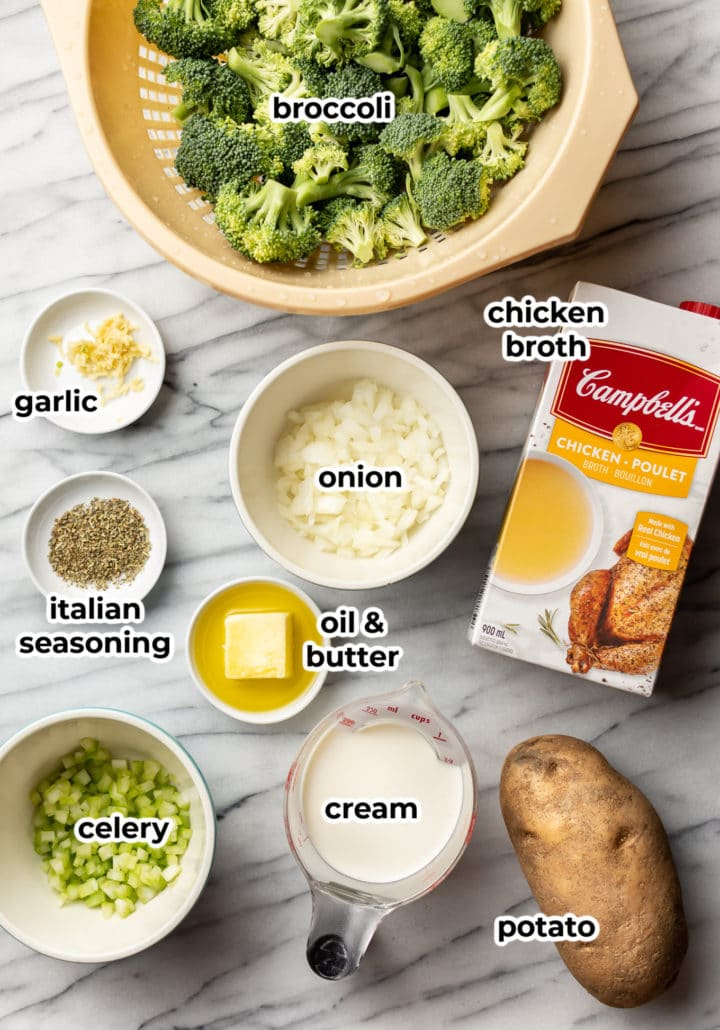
left=42, top=0, right=638, bottom=314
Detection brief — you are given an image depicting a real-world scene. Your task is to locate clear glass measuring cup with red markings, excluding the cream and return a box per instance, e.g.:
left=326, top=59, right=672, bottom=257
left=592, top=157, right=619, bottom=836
left=284, top=681, right=477, bottom=980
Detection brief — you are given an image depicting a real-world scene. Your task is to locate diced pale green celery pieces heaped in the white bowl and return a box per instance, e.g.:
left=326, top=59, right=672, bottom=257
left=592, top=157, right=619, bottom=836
left=30, top=737, right=193, bottom=919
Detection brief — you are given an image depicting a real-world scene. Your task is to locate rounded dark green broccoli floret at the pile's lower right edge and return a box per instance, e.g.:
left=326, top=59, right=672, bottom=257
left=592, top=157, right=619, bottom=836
left=413, top=152, right=492, bottom=230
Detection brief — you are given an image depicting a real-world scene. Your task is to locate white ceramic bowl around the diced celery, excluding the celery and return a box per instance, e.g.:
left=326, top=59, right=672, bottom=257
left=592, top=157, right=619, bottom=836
left=0, top=708, right=216, bottom=962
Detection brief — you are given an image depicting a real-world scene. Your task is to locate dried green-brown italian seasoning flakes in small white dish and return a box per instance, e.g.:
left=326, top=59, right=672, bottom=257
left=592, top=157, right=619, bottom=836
left=47, top=497, right=150, bottom=590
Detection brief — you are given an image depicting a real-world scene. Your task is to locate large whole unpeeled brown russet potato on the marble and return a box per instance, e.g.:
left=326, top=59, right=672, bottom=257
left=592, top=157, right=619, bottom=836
left=500, top=735, right=687, bottom=1008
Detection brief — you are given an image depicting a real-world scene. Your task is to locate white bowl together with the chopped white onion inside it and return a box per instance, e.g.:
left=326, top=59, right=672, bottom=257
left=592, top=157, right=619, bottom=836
left=230, top=341, right=479, bottom=590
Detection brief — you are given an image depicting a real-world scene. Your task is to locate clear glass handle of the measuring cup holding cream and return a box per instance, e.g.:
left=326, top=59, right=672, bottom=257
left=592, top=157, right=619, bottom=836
left=306, top=889, right=384, bottom=980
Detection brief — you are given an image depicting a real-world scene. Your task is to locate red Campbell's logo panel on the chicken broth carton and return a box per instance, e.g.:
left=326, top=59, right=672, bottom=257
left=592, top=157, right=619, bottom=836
left=550, top=340, right=720, bottom=457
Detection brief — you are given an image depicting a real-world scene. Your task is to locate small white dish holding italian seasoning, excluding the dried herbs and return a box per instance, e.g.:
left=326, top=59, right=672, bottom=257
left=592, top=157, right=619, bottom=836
left=23, top=472, right=167, bottom=600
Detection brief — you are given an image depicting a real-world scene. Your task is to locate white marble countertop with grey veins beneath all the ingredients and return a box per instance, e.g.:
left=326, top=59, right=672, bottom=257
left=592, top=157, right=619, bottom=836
left=0, top=0, right=720, bottom=1030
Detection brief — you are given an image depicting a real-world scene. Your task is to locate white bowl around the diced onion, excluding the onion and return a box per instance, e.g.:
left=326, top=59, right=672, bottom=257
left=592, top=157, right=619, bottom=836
left=230, top=341, right=479, bottom=590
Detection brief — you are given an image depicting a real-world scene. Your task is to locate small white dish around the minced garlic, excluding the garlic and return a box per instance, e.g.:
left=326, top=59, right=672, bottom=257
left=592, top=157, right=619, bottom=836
left=20, top=289, right=165, bottom=434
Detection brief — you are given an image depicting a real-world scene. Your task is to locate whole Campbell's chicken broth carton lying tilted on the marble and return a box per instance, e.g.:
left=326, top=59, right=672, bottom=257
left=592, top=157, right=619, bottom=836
left=470, top=283, right=720, bottom=695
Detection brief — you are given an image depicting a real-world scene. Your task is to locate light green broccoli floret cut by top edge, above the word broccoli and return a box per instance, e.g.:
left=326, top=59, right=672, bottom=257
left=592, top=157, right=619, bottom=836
left=293, top=0, right=387, bottom=65
